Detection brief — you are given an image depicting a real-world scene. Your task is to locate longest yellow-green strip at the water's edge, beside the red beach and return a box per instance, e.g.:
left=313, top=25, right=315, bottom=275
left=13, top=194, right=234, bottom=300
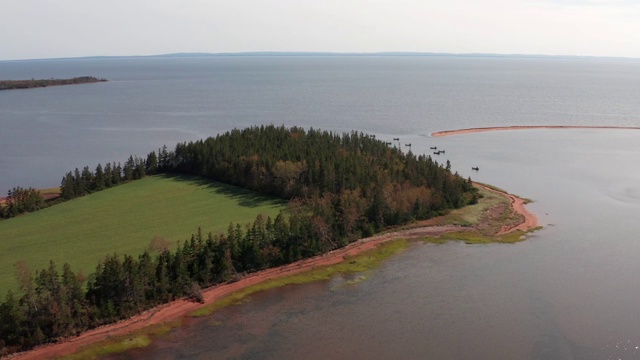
left=191, top=239, right=409, bottom=317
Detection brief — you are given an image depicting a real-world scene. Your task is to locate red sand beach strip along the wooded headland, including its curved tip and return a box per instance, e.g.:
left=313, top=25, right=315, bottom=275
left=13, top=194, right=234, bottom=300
left=9, top=184, right=537, bottom=360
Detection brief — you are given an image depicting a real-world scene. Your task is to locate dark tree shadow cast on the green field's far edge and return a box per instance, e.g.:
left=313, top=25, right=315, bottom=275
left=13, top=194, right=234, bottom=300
left=157, top=173, right=287, bottom=208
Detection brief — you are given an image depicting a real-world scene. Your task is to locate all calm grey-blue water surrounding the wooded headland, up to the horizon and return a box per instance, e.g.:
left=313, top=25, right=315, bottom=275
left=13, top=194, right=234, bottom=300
left=0, top=57, right=640, bottom=359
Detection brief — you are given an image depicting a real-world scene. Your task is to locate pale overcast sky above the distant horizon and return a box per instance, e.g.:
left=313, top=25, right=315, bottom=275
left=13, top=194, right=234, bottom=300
left=0, top=0, right=640, bottom=60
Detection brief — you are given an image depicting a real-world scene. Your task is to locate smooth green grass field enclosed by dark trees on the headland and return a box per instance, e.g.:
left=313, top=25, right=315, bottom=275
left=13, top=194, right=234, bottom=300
left=0, top=176, right=286, bottom=299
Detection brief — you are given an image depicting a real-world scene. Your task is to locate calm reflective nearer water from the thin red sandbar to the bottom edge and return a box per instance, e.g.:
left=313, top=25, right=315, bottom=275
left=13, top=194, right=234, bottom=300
left=107, top=130, right=640, bottom=359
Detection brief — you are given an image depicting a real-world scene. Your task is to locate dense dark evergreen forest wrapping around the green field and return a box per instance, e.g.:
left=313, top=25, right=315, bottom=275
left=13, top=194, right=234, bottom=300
left=0, top=126, right=478, bottom=354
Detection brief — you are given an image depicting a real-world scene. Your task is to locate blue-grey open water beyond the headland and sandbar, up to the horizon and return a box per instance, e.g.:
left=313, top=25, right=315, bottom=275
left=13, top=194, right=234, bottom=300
left=0, top=56, right=640, bottom=194
